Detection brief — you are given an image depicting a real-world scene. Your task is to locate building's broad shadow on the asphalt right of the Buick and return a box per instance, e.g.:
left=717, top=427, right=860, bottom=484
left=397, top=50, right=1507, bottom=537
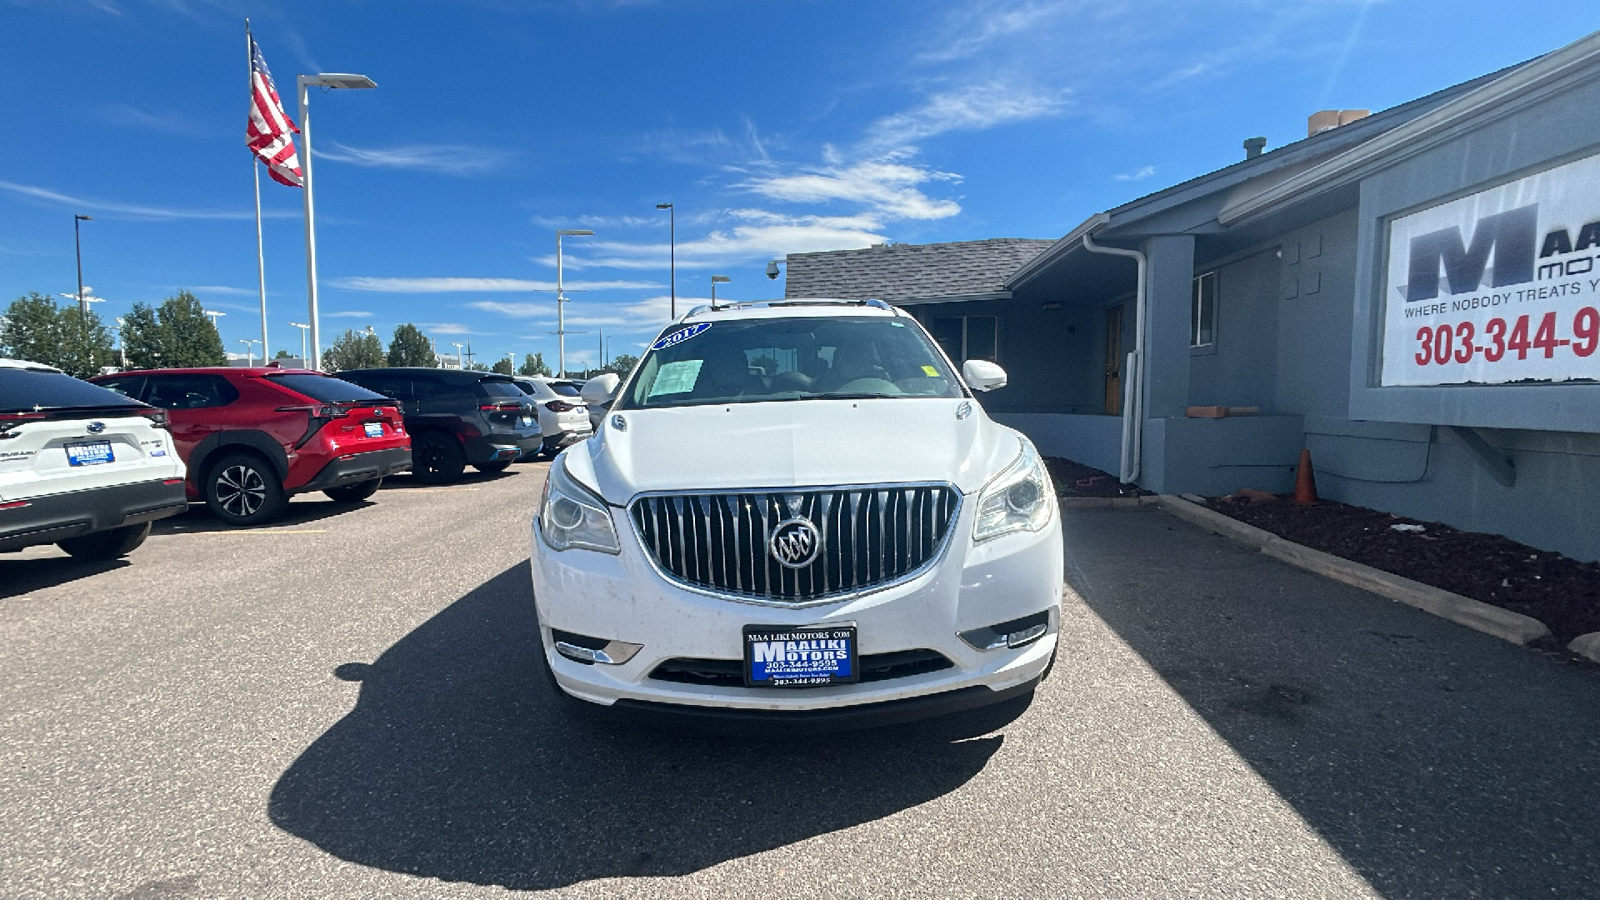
left=1067, top=511, right=1600, bottom=897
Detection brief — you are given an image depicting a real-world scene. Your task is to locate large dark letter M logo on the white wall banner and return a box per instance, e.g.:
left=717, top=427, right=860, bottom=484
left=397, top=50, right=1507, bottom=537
left=1405, top=203, right=1539, bottom=303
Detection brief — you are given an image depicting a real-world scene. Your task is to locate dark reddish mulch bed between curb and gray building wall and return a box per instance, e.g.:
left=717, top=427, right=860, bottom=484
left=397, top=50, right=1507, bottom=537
left=1208, top=495, right=1600, bottom=649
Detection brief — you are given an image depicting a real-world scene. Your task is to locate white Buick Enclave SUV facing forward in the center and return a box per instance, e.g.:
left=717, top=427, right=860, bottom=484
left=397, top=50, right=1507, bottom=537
left=531, top=299, right=1062, bottom=725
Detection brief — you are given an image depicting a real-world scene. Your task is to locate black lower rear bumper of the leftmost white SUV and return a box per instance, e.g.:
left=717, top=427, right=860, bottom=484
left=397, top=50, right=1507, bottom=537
left=0, top=477, right=189, bottom=551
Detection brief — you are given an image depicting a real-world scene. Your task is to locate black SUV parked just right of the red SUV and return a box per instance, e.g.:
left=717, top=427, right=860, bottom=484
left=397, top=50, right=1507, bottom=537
left=339, top=367, right=544, bottom=484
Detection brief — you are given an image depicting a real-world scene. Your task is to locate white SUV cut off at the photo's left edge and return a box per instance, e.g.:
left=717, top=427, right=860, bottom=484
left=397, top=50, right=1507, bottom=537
left=0, top=359, right=189, bottom=559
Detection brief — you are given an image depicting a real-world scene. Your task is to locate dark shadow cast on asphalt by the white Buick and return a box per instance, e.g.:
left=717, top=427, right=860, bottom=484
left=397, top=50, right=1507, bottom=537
left=269, top=562, right=1019, bottom=890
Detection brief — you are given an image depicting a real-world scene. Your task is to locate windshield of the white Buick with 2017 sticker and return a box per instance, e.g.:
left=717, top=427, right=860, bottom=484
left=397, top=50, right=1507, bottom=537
left=621, top=315, right=965, bottom=408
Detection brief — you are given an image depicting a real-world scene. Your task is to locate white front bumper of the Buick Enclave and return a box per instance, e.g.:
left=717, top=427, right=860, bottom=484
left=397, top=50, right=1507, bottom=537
left=531, top=493, right=1062, bottom=724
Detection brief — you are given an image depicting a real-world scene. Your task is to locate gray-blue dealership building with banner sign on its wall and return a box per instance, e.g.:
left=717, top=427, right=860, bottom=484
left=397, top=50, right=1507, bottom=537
left=786, top=34, right=1600, bottom=560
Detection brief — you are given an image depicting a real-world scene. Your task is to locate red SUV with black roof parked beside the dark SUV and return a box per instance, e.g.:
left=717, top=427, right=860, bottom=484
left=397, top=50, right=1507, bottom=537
left=90, top=367, right=411, bottom=525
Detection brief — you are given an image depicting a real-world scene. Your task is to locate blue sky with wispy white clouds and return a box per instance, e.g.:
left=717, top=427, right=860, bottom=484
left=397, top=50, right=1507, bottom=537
left=0, top=0, right=1595, bottom=367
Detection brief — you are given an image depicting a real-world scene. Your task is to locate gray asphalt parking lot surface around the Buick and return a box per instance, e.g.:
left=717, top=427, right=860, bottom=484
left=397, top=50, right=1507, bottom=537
left=0, top=464, right=1600, bottom=898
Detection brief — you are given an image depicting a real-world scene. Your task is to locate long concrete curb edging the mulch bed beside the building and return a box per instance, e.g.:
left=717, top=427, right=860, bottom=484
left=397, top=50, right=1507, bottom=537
left=1158, top=495, right=1555, bottom=643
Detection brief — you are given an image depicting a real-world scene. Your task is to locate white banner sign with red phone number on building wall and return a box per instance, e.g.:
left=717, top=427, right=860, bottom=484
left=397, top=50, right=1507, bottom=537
left=1379, top=148, right=1600, bottom=388
